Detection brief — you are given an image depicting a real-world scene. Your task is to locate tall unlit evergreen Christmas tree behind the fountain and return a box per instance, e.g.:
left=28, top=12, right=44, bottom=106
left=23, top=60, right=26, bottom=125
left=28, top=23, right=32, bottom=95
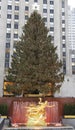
left=7, top=11, right=63, bottom=94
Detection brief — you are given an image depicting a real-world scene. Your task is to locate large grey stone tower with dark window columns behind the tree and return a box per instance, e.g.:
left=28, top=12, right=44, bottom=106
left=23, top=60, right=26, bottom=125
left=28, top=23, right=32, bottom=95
left=0, top=0, right=69, bottom=96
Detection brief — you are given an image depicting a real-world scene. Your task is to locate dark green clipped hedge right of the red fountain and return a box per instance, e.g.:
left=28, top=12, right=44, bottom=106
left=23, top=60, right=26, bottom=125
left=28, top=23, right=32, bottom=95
left=63, top=104, right=75, bottom=115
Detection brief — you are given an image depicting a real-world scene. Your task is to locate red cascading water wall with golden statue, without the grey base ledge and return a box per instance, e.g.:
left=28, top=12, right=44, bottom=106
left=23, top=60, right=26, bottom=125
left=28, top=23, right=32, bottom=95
left=11, top=98, right=59, bottom=126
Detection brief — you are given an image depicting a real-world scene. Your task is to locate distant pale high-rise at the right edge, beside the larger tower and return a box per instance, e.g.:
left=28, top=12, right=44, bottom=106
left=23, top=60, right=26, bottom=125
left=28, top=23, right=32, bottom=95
left=68, top=7, right=75, bottom=75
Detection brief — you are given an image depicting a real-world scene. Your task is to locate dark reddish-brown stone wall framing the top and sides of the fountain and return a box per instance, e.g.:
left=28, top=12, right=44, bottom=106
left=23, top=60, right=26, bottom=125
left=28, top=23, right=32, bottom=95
left=0, top=97, right=75, bottom=119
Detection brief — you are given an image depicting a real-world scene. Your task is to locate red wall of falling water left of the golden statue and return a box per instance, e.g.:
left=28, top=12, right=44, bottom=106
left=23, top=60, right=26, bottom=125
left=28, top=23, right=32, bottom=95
left=11, top=101, right=29, bottom=124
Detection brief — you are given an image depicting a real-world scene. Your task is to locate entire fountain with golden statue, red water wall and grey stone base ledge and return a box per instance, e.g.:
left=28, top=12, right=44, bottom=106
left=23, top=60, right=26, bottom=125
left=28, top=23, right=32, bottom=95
left=5, top=98, right=73, bottom=130
